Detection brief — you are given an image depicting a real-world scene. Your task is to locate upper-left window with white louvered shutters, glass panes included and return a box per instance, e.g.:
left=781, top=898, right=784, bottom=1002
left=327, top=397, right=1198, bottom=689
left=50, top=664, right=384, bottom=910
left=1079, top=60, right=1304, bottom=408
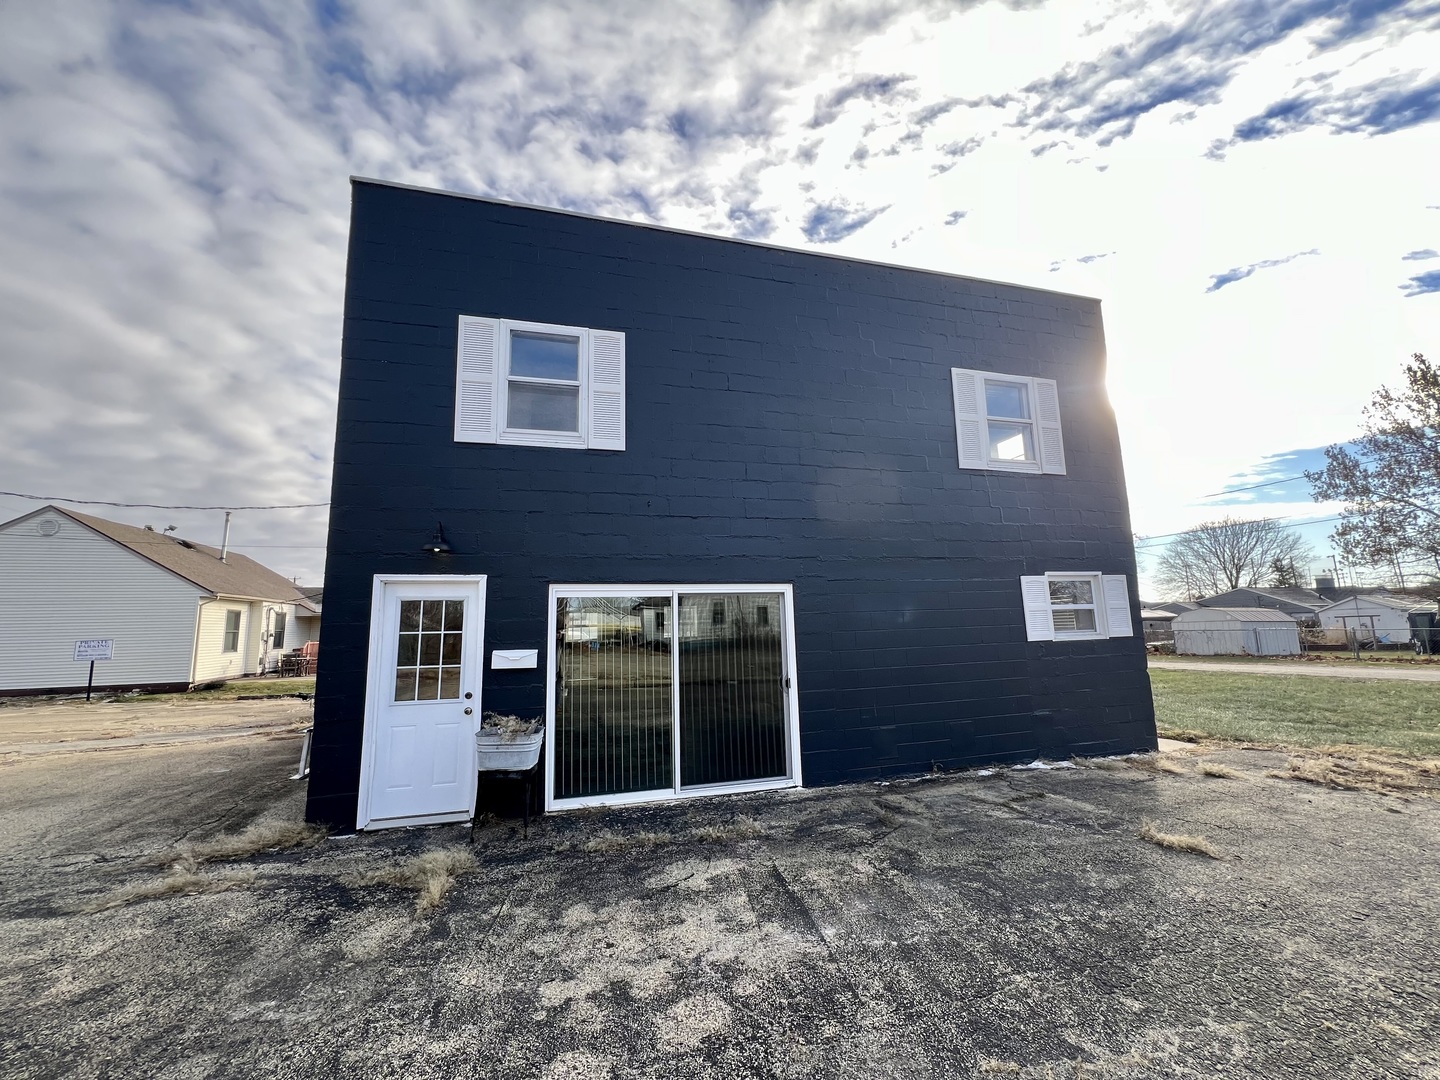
left=455, top=315, right=625, bottom=451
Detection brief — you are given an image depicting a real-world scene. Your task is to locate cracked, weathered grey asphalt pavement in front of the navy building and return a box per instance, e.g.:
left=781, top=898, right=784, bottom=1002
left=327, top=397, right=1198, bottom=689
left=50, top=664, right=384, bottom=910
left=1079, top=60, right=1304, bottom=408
left=0, top=703, right=1440, bottom=1080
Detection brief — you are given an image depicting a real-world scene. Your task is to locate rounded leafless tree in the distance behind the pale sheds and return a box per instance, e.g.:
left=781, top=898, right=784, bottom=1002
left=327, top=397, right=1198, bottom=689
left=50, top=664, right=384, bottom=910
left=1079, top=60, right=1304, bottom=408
left=1155, top=517, right=1312, bottom=600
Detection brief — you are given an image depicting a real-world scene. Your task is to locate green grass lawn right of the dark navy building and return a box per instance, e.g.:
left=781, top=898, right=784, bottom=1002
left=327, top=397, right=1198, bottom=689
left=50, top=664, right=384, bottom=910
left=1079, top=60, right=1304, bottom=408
left=1151, top=670, right=1440, bottom=757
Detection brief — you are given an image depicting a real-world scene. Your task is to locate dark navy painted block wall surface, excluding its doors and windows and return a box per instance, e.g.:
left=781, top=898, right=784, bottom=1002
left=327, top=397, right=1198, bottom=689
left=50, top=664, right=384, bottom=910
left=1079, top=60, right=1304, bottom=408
left=310, top=181, right=1155, bottom=827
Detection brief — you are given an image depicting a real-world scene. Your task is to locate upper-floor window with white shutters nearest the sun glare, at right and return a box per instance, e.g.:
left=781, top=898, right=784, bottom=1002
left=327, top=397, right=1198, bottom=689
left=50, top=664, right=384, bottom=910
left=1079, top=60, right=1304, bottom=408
left=950, top=367, right=1066, bottom=474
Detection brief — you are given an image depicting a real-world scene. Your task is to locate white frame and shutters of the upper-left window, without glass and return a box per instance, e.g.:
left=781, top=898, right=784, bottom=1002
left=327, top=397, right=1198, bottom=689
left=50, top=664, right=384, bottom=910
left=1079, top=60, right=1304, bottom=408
left=455, top=315, right=625, bottom=451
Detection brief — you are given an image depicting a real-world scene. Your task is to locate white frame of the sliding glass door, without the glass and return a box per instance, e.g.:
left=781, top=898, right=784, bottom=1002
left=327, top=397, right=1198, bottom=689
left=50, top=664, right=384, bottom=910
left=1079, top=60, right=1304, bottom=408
left=544, top=582, right=802, bottom=812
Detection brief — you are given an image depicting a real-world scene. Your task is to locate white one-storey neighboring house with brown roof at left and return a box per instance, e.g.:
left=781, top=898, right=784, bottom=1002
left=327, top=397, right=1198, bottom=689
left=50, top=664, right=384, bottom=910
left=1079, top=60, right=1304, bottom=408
left=0, top=507, right=320, bottom=694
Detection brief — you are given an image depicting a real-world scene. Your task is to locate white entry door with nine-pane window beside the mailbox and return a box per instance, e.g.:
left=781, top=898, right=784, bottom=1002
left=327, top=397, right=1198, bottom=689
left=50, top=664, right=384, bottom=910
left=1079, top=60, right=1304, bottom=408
left=359, top=576, right=485, bottom=829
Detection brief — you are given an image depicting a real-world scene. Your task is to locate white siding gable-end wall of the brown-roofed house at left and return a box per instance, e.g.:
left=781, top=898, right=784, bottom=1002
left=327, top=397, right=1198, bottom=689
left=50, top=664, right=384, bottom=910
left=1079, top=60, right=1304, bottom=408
left=0, top=514, right=203, bottom=690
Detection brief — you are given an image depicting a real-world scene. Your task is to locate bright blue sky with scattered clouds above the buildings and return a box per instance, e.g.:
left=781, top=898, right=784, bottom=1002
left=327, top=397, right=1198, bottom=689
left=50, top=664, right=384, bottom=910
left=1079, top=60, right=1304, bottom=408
left=0, top=0, right=1440, bottom=596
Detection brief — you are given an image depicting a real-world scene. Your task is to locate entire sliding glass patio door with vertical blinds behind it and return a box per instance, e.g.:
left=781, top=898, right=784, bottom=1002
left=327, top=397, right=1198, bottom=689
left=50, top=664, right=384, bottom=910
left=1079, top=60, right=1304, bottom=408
left=546, top=585, right=799, bottom=809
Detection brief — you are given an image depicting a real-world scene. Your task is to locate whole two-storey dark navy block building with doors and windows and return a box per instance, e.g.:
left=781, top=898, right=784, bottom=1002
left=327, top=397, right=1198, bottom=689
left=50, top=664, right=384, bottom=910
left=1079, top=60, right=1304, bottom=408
left=308, top=180, right=1155, bottom=829
